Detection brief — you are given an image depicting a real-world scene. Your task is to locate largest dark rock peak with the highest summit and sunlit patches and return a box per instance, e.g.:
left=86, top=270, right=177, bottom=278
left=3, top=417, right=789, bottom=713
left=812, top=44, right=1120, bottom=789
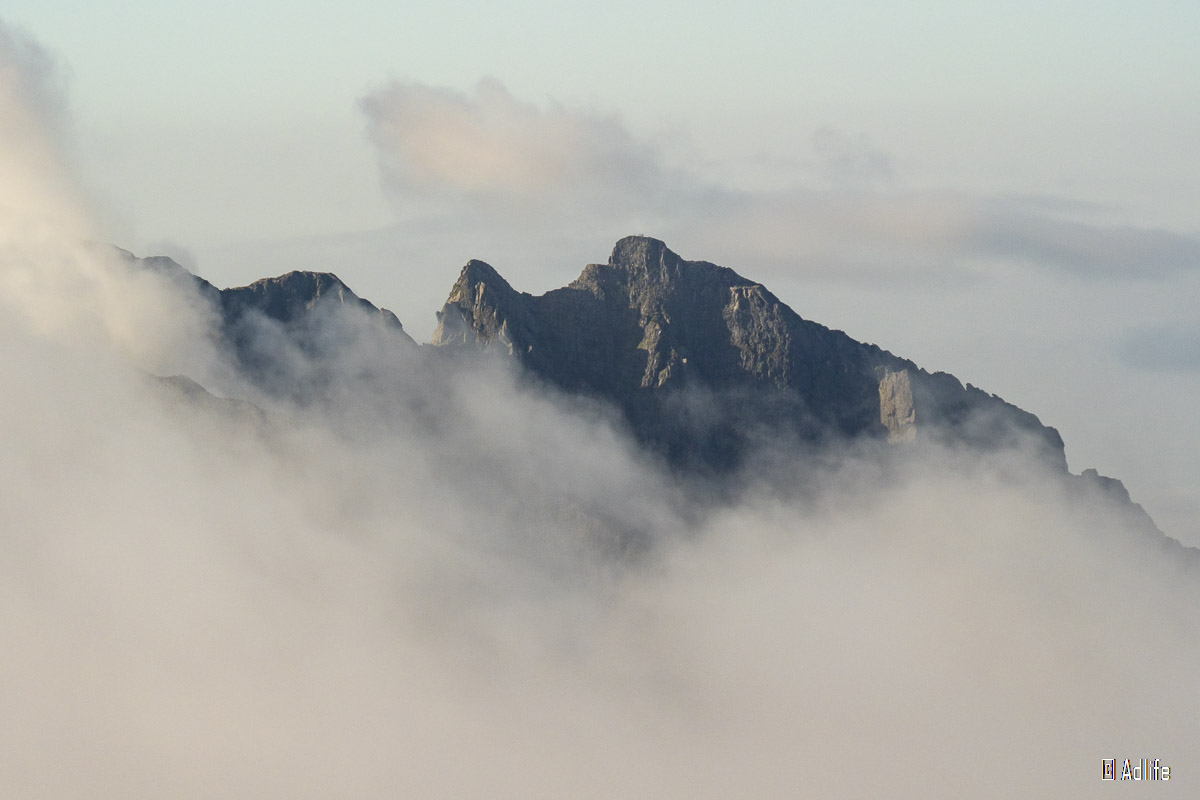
left=433, top=236, right=1066, bottom=473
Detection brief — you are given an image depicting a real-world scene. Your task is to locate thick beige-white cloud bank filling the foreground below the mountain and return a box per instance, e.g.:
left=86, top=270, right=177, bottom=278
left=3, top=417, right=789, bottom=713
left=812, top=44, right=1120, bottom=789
left=0, top=277, right=1200, bottom=798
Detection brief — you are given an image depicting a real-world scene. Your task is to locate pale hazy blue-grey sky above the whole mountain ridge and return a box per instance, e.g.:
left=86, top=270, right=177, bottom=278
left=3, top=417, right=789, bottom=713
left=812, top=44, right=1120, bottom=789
left=2, top=0, right=1200, bottom=545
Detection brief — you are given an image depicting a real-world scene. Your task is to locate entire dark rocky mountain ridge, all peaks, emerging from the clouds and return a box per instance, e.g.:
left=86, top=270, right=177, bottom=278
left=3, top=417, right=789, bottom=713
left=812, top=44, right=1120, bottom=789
left=120, top=236, right=1176, bottom=551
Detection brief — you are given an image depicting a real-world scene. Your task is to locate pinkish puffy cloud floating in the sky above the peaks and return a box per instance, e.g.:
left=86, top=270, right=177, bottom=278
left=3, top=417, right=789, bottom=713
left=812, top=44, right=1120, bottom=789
left=362, top=79, right=686, bottom=221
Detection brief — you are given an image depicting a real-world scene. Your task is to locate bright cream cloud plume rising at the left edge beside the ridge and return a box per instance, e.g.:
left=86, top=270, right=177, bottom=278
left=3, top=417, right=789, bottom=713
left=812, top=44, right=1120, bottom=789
left=0, top=24, right=225, bottom=388
